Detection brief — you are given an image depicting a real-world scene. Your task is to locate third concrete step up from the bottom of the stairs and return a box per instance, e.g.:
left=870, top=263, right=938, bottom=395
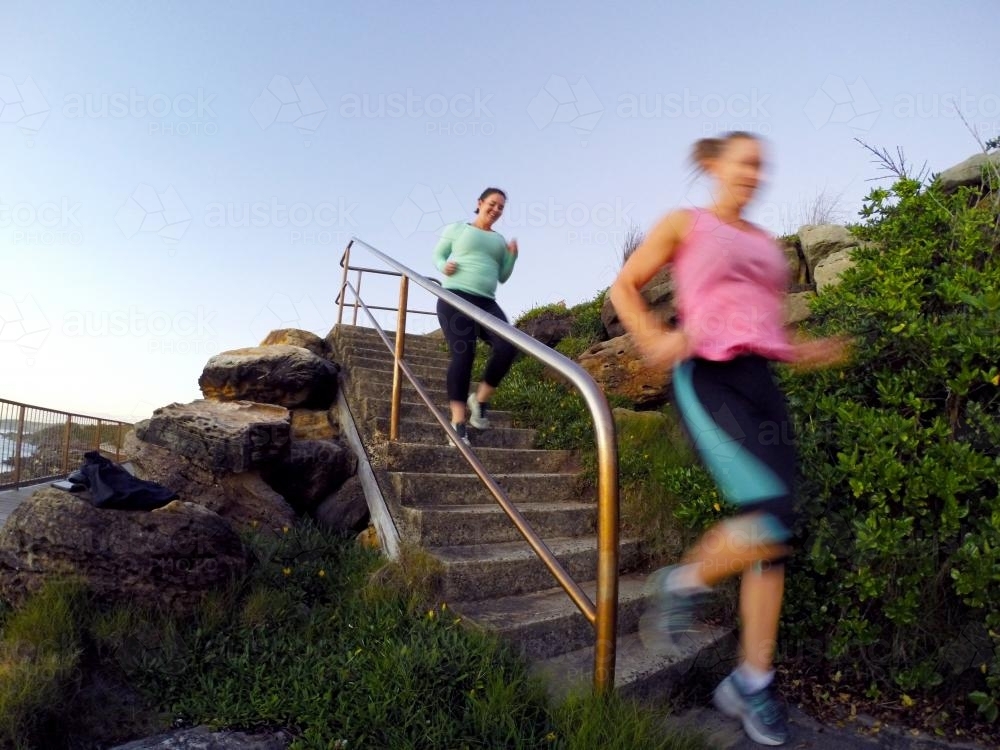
left=426, top=536, right=639, bottom=602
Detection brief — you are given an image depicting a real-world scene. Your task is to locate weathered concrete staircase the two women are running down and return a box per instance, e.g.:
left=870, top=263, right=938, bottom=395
left=328, top=326, right=735, bottom=697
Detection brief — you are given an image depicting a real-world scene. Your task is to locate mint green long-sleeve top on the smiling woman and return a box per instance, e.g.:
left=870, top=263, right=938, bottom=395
left=434, top=222, right=517, bottom=299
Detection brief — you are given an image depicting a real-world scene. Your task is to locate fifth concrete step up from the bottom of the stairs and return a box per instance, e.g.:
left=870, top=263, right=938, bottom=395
left=388, top=471, right=581, bottom=508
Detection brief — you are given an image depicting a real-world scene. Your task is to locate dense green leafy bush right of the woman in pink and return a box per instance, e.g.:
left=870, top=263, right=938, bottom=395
left=785, top=179, right=1000, bottom=716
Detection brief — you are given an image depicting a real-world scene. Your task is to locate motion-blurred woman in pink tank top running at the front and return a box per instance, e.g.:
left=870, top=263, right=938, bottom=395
left=609, top=133, right=846, bottom=745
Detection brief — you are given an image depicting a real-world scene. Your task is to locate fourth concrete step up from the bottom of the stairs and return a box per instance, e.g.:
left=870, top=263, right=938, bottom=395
left=401, top=502, right=597, bottom=548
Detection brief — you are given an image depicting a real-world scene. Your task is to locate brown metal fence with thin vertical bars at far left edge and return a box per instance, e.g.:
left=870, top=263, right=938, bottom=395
left=0, top=398, right=131, bottom=489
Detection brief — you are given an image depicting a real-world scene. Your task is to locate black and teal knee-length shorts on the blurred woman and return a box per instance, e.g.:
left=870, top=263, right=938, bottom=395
left=673, top=355, right=798, bottom=543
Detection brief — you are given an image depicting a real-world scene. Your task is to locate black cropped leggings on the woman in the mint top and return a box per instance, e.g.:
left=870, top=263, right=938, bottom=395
left=437, top=289, right=517, bottom=401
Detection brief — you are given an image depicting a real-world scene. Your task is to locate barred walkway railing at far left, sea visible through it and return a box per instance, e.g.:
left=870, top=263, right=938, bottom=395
left=0, top=399, right=131, bottom=490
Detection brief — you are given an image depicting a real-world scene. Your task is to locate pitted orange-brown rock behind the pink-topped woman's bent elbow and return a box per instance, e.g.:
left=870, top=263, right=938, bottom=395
left=579, top=334, right=670, bottom=405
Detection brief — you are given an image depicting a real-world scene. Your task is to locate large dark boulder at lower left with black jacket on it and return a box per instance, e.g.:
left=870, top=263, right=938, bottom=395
left=0, top=487, right=248, bottom=614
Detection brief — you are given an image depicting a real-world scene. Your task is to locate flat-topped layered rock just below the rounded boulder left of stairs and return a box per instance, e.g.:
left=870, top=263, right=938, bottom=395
left=135, top=399, right=290, bottom=472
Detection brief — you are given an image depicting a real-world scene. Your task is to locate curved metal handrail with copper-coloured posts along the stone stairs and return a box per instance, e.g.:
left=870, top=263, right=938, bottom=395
left=337, top=237, right=618, bottom=692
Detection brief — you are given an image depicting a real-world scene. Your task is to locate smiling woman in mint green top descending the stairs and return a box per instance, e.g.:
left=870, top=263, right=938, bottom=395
left=434, top=188, right=517, bottom=445
